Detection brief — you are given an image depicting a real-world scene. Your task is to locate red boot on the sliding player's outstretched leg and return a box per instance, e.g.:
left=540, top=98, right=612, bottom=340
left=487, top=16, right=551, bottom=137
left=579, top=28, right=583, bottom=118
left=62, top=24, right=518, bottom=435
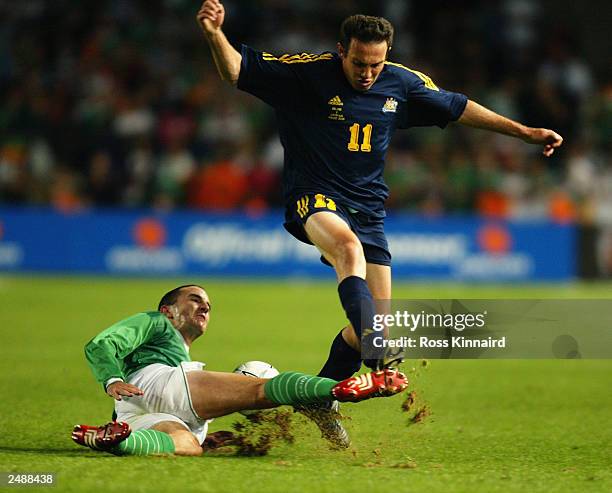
left=332, top=368, right=408, bottom=402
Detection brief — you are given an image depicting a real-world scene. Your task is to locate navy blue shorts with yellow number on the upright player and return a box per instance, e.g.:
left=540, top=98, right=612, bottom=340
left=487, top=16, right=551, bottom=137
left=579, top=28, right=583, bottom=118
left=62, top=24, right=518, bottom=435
left=284, top=193, right=391, bottom=265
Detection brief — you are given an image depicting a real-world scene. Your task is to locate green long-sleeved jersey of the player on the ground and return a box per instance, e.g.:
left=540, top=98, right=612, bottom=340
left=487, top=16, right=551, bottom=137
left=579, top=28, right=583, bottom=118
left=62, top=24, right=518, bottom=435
left=85, top=312, right=191, bottom=385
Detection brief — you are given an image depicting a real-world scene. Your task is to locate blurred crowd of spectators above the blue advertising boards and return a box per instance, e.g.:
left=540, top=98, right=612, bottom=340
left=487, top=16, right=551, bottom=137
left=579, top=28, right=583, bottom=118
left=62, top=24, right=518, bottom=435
left=0, top=0, right=612, bottom=222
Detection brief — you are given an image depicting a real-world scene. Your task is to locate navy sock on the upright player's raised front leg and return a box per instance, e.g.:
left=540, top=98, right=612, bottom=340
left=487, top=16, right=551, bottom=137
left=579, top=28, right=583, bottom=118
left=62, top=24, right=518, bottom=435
left=338, top=276, right=381, bottom=368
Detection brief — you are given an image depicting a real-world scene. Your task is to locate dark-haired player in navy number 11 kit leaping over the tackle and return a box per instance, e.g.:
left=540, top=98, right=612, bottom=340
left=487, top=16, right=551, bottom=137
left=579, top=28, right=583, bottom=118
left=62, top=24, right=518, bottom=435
left=197, top=0, right=563, bottom=446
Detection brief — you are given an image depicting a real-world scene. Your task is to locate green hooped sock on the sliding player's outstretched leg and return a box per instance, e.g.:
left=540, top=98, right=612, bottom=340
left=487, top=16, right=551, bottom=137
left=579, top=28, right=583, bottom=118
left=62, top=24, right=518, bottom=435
left=264, top=371, right=338, bottom=405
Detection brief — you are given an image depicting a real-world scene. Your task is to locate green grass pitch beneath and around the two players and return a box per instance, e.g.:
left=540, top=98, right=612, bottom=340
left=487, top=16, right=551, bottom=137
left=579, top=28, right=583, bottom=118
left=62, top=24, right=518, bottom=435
left=0, top=276, right=612, bottom=493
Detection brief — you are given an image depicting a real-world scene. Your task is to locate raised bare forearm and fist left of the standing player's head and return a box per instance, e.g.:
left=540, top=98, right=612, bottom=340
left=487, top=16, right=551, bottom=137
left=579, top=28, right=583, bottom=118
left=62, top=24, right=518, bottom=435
left=197, top=0, right=242, bottom=85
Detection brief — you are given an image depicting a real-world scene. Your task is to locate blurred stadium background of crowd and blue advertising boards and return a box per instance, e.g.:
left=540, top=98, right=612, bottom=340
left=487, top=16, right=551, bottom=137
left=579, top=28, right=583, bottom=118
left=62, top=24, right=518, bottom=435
left=0, top=0, right=612, bottom=281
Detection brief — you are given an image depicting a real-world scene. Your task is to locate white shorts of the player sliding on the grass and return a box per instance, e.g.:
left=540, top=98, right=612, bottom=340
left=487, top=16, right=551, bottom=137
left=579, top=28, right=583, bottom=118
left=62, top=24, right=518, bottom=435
left=115, top=361, right=212, bottom=443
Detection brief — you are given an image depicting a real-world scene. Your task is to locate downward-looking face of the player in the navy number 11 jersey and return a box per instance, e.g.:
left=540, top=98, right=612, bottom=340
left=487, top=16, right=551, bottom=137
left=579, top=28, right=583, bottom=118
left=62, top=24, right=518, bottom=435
left=338, top=39, right=388, bottom=92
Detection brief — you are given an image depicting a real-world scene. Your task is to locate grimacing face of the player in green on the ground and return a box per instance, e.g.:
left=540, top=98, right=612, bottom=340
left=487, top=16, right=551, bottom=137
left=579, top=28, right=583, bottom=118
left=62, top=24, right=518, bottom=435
left=168, top=286, right=210, bottom=338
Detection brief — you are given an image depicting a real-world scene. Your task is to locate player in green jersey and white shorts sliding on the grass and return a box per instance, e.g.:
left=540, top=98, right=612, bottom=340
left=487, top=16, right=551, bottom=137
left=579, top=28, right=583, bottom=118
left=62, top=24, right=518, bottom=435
left=72, top=285, right=407, bottom=455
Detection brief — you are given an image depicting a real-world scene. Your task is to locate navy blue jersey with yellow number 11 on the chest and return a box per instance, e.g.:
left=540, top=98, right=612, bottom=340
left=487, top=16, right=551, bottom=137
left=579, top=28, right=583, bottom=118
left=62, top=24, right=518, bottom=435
left=238, top=45, right=467, bottom=217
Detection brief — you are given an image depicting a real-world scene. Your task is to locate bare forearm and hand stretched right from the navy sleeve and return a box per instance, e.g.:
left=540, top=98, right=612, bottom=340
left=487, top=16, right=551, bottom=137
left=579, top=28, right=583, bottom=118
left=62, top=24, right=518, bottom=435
left=458, top=100, right=563, bottom=157
